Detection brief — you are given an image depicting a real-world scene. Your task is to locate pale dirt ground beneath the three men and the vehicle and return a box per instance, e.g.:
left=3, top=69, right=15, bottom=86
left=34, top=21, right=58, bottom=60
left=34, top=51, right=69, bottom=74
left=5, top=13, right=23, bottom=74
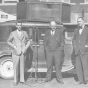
left=0, top=71, right=88, bottom=88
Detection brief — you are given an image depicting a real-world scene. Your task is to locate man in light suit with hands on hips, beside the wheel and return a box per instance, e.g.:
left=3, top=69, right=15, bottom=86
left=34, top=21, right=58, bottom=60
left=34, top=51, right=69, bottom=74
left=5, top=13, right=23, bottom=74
left=7, top=22, right=30, bottom=86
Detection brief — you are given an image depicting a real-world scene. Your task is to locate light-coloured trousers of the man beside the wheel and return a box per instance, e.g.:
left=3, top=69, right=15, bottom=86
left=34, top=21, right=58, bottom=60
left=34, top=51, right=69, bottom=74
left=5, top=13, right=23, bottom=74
left=12, top=54, right=25, bottom=82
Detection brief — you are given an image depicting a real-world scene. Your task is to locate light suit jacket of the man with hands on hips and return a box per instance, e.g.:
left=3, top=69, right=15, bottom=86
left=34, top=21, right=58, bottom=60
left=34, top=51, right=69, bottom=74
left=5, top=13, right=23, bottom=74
left=7, top=30, right=30, bottom=55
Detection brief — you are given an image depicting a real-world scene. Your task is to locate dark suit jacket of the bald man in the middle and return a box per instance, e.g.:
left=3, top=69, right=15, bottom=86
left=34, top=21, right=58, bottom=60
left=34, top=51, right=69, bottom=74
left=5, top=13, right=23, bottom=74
left=44, top=28, right=64, bottom=52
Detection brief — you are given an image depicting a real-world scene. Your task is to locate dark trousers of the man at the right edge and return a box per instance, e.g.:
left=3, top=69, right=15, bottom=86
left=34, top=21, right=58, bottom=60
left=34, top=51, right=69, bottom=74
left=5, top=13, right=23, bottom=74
left=76, top=52, right=88, bottom=82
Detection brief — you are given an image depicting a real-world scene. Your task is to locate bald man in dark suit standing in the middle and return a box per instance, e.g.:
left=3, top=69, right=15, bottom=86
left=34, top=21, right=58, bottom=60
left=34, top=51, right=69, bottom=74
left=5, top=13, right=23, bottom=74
left=44, top=21, right=64, bottom=84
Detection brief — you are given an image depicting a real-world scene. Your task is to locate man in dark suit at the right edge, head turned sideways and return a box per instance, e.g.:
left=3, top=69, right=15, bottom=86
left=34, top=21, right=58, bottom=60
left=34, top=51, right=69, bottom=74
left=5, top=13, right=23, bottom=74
left=73, top=17, right=88, bottom=85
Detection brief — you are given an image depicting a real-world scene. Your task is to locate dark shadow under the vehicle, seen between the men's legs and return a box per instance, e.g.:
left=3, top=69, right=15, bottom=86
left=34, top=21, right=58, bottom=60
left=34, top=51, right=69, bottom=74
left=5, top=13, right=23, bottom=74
left=25, top=69, right=78, bottom=81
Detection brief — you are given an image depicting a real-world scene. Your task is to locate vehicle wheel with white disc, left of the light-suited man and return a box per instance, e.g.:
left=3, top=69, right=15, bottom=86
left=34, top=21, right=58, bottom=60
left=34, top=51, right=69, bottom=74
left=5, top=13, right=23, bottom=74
left=0, top=56, right=14, bottom=79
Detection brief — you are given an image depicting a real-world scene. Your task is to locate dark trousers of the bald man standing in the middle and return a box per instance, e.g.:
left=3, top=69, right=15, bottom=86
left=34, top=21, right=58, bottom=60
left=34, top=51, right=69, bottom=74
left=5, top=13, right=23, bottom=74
left=46, top=51, right=62, bottom=80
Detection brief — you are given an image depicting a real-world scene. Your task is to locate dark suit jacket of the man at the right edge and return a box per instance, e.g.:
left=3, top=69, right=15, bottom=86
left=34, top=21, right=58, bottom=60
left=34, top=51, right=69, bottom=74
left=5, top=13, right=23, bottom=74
left=73, top=26, right=88, bottom=54
